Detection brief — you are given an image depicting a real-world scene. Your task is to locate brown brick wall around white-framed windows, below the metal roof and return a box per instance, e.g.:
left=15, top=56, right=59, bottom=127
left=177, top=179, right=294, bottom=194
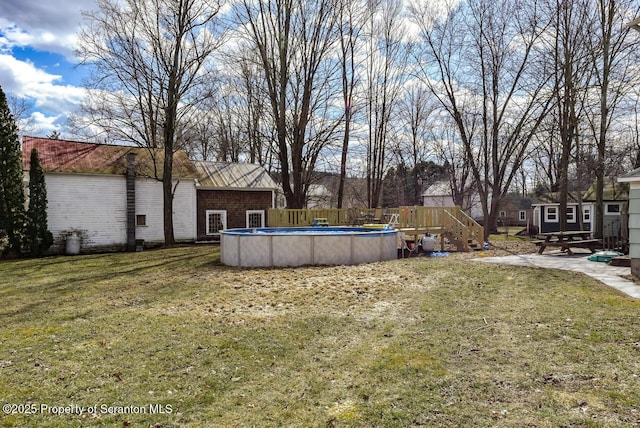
left=197, top=190, right=271, bottom=241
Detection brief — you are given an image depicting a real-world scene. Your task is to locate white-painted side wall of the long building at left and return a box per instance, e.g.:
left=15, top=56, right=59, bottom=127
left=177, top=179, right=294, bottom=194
left=45, top=173, right=196, bottom=252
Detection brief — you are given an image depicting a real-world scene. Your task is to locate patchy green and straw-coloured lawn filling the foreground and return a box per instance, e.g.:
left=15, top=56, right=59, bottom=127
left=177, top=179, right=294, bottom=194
left=0, top=246, right=640, bottom=427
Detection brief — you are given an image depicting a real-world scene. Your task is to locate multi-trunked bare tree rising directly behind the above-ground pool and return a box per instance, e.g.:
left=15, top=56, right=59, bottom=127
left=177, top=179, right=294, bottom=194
left=238, top=0, right=339, bottom=208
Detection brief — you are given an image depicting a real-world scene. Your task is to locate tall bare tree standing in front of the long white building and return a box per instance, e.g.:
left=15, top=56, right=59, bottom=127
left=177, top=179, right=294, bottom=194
left=77, top=0, right=220, bottom=245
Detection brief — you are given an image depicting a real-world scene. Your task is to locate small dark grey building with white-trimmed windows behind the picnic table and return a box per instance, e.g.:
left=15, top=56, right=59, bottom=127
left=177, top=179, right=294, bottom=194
left=532, top=177, right=628, bottom=236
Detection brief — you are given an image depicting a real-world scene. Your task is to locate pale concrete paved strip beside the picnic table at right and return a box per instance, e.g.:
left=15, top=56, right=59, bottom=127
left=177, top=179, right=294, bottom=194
left=473, top=251, right=640, bottom=299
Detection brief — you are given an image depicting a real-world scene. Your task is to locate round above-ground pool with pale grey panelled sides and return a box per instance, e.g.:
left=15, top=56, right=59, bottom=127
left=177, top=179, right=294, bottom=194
left=220, top=227, right=398, bottom=267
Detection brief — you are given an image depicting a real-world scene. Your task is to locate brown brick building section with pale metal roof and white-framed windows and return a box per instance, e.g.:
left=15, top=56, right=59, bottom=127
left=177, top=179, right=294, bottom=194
left=194, top=162, right=278, bottom=241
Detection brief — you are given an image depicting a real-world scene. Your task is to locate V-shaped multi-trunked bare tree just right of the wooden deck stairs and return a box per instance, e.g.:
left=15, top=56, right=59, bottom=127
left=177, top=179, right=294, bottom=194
left=412, top=0, right=551, bottom=238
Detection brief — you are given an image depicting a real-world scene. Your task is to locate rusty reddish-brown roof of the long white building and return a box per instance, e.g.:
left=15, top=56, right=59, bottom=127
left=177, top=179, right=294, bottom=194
left=22, top=136, right=197, bottom=178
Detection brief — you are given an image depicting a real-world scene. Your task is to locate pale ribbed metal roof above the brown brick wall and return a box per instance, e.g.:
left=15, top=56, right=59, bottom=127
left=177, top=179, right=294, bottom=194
left=194, top=161, right=278, bottom=190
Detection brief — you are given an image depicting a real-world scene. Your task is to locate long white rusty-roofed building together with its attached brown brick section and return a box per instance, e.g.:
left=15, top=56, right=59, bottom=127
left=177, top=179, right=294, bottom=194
left=22, top=137, right=275, bottom=253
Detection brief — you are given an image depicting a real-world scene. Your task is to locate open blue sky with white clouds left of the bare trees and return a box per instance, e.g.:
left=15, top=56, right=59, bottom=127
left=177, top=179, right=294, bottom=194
left=0, top=0, right=95, bottom=138
